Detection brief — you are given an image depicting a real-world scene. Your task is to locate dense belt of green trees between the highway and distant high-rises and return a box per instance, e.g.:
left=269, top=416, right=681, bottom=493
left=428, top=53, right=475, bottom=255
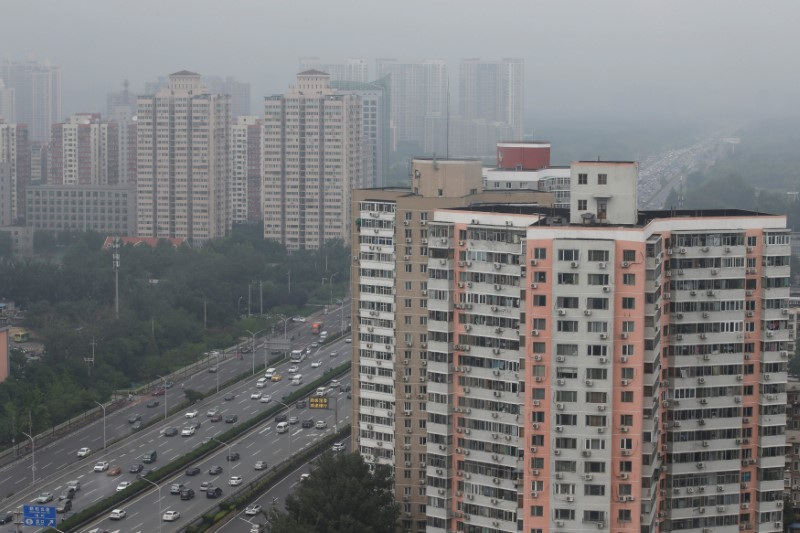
left=0, top=227, right=350, bottom=445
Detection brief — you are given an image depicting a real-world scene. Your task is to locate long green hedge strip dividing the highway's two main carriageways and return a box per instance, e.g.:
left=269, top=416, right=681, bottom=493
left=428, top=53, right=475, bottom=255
left=46, top=361, right=351, bottom=533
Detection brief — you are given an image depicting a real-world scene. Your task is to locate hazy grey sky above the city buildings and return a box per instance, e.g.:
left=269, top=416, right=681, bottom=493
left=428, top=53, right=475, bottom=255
left=0, top=0, right=800, bottom=131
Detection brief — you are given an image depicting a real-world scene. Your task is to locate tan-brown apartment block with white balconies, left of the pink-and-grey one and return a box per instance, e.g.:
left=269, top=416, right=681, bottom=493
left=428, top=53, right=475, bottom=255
left=351, top=158, right=552, bottom=531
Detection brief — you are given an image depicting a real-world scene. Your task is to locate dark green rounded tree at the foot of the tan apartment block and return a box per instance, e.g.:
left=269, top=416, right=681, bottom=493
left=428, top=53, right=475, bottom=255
left=269, top=453, right=400, bottom=533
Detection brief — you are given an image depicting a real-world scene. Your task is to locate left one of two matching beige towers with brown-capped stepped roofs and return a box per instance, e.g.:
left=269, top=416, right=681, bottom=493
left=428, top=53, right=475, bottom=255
left=136, top=71, right=231, bottom=243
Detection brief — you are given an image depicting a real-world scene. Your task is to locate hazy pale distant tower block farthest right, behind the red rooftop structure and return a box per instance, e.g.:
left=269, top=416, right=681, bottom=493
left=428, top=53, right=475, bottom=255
left=458, top=58, right=525, bottom=139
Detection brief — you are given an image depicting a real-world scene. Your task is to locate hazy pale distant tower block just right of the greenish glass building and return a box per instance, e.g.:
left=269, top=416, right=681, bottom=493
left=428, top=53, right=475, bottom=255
left=377, top=59, right=448, bottom=154
